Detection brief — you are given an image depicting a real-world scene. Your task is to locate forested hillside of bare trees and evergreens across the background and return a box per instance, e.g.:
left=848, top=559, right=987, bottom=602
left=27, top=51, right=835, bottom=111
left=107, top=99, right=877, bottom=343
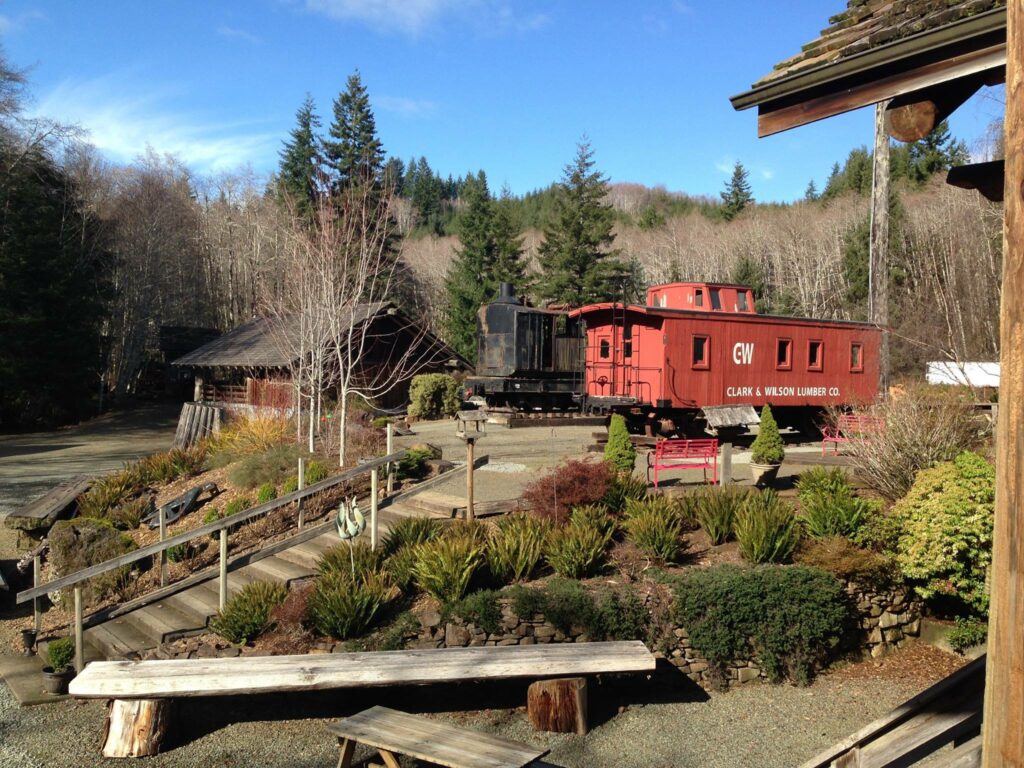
left=0, top=51, right=1001, bottom=428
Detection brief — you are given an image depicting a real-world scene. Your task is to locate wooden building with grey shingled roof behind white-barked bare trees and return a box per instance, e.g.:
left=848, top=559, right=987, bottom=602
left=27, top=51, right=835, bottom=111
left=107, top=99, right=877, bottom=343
left=173, top=302, right=470, bottom=411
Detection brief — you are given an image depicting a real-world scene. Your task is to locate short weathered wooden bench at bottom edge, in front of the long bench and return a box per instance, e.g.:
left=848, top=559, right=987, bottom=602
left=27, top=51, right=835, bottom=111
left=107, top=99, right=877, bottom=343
left=328, top=707, right=550, bottom=768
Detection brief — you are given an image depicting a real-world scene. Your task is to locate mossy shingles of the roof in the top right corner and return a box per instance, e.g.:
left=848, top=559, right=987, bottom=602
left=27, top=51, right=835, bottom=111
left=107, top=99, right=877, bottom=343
left=755, top=0, right=1007, bottom=87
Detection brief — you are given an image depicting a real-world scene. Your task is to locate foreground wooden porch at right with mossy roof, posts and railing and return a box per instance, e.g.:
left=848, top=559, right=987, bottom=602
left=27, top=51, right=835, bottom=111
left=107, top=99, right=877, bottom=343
left=732, top=0, right=1024, bottom=768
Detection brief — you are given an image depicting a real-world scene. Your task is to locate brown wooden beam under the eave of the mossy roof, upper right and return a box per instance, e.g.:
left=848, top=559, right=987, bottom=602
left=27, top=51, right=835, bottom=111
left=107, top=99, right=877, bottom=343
left=758, top=43, right=1007, bottom=137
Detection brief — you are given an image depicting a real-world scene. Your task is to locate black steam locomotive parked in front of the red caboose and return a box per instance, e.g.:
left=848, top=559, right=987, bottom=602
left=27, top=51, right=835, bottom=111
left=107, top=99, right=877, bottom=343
left=465, top=283, right=586, bottom=411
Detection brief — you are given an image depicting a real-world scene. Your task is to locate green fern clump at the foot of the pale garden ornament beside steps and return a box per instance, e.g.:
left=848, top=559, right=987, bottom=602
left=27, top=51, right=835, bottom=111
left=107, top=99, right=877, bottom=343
left=308, top=570, right=395, bottom=640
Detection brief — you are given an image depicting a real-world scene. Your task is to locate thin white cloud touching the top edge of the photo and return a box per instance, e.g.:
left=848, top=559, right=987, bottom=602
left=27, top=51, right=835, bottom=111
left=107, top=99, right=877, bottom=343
left=305, top=0, right=551, bottom=37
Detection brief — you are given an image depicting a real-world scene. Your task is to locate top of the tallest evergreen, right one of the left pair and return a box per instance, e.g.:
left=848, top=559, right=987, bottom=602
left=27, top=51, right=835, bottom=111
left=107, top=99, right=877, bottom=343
left=324, top=71, right=384, bottom=188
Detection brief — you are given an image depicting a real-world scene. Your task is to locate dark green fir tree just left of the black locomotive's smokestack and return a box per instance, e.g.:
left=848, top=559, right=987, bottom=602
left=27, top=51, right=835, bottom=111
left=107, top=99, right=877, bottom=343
left=444, top=171, right=495, bottom=361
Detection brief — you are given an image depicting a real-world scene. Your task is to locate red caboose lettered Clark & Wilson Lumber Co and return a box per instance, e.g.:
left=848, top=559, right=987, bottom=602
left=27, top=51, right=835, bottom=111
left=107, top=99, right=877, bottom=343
left=569, top=283, right=881, bottom=434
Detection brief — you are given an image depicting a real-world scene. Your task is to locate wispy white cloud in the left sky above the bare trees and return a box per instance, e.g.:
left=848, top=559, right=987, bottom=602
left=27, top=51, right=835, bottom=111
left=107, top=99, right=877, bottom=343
left=35, top=75, right=281, bottom=173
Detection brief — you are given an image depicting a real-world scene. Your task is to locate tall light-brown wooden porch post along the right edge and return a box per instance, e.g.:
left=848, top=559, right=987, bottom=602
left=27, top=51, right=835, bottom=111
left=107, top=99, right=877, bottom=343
left=982, top=0, right=1024, bottom=768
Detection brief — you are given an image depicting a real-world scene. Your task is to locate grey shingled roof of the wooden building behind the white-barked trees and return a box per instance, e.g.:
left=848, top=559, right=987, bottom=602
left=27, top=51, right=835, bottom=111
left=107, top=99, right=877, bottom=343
left=172, top=302, right=388, bottom=369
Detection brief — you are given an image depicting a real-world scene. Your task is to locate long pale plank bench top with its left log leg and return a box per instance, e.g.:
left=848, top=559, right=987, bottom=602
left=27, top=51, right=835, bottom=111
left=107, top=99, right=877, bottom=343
left=70, top=640, right=655, bottom=757
